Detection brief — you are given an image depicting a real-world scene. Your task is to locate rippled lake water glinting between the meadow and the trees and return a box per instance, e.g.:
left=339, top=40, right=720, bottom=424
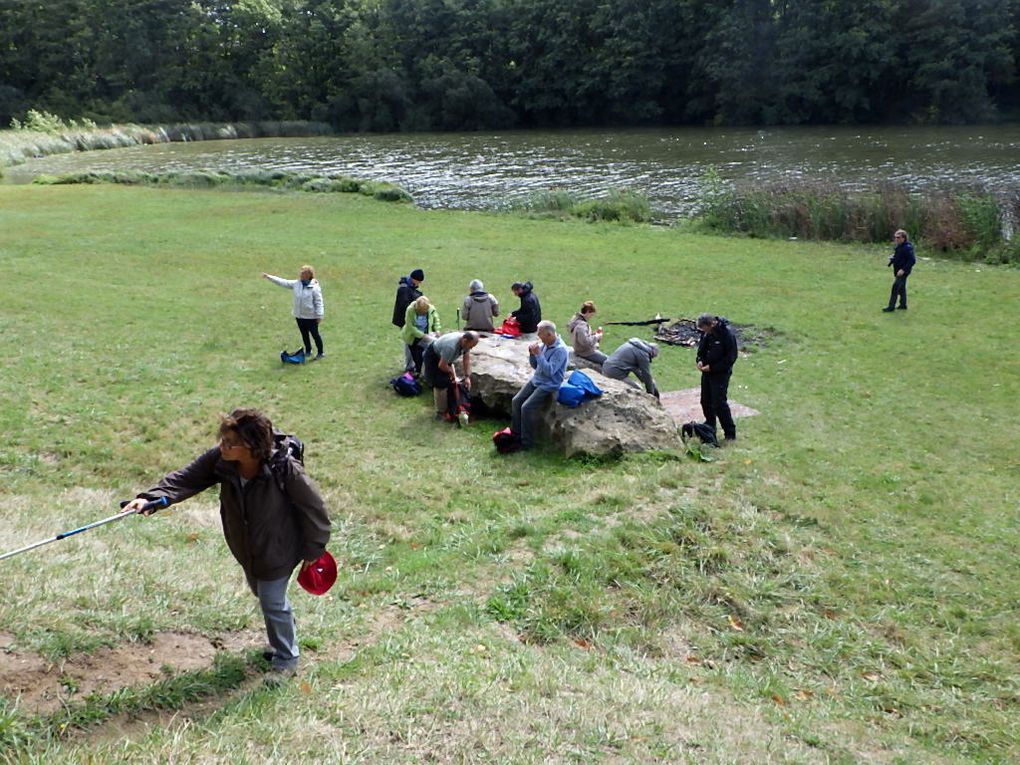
left=7, top=125, right=1020, bottom=217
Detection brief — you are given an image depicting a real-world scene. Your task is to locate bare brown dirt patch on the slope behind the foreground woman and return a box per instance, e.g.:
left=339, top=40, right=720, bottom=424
left=0, top=632, right=216, bottom=714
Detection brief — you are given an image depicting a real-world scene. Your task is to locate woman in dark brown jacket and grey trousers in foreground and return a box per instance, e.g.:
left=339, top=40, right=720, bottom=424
left=124, top=409, right=330, bottom=674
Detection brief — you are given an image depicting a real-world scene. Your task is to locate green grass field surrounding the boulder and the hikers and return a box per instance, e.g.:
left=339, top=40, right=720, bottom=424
left=0, top=187, right=1020, bottom=763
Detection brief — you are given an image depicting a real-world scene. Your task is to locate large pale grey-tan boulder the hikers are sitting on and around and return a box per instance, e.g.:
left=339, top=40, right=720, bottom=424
left=471, top=336, right=680, bottom=457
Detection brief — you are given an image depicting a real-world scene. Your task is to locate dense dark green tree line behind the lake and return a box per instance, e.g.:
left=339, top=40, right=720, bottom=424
left=0, top=0, right=1020, bottom=131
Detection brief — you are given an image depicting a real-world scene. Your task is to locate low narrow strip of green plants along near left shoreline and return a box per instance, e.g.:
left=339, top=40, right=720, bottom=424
left=33, top=170, right=413, bottom=202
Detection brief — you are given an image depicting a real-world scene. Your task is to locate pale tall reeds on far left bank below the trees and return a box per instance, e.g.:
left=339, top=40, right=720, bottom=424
left=0, top=115, right=333, bottom=171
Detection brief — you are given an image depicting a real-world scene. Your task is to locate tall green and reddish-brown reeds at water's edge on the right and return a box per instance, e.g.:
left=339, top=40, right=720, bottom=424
left=696, top=171, right=1017, bottom=262
